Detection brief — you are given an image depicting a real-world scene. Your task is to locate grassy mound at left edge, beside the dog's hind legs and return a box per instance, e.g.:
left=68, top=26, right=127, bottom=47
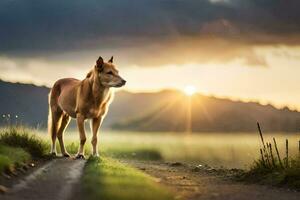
left=0, top=126, right=48, bottom=174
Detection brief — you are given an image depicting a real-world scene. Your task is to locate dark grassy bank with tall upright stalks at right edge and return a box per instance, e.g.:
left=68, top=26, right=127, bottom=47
left=242, top=124, right=300, bottom=190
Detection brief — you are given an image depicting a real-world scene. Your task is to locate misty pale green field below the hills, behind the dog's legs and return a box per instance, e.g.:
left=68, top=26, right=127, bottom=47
left=60, top=131, right=300, bottom=169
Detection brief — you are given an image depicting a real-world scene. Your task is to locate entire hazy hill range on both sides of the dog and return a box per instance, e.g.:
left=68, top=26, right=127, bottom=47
left=0, top=81, right=300, bottom=132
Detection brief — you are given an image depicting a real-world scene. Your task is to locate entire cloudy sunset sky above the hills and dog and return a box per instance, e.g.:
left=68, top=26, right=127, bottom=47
left=0, top=0, right=300, bottom=110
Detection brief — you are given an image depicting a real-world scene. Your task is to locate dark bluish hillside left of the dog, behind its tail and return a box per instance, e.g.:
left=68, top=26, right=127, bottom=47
left=0, top=80, right=49, bottom=127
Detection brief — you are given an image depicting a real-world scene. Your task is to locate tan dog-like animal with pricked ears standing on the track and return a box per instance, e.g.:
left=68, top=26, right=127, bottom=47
left=48, top=57, right=126, bottom=158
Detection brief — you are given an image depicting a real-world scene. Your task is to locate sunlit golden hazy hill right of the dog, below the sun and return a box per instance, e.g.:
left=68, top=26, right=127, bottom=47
left=112, top=91, right=300, bottom=132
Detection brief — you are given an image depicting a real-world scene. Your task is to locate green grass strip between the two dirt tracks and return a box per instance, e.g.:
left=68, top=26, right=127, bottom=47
left=83, top=157, right=173, bottom=200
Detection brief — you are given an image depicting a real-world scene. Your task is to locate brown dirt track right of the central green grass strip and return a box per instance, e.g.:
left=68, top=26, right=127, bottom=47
left=123, top=161, right=300, bottom=200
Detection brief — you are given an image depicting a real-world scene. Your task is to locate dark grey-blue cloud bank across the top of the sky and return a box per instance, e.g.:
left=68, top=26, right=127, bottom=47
left=0, top=0, right=300, bottom=63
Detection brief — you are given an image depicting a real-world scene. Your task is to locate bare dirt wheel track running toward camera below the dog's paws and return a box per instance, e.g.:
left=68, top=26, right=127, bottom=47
left=0, top=158, right=85, bottom=200
